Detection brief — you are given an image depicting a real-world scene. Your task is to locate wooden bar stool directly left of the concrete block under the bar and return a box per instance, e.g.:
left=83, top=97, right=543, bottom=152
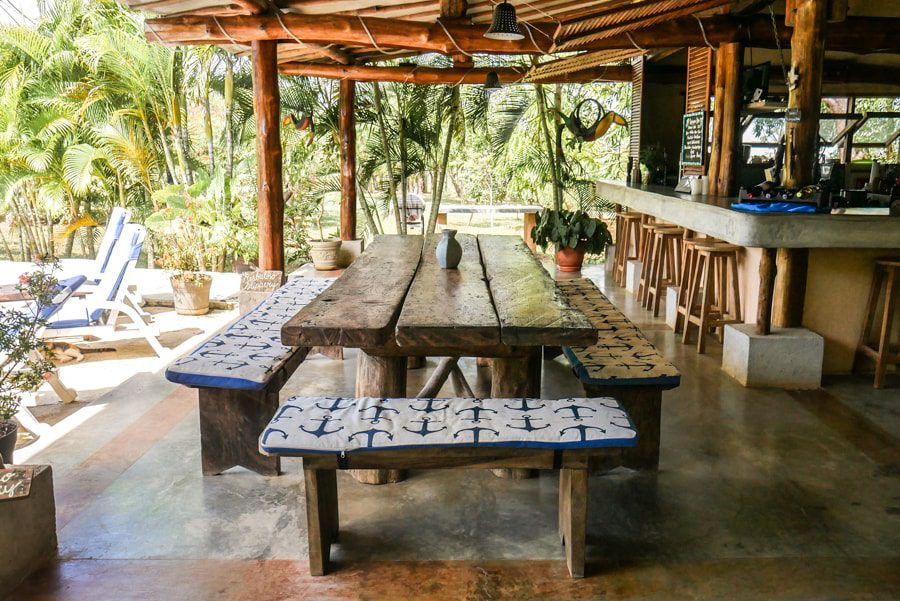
left=679, top=240, right=743, bottom=354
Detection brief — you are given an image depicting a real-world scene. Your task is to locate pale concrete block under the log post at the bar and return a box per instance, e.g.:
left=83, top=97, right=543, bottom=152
left=722, top=324, right=825, bottom=390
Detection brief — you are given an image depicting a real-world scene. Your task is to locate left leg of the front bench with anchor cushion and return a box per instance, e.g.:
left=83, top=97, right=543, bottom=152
left=303, top=468, right=337, bottom=576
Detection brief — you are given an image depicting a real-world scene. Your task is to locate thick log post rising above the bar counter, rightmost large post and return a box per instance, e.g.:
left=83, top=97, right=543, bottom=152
left=784, top=0, right=828, bottom=188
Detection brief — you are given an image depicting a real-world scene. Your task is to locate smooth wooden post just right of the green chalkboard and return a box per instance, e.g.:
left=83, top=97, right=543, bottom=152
left=709, top=42, right=744, bottom=196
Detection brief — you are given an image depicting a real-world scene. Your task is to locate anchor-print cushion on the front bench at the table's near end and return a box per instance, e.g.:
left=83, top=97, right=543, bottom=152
left=259, top=397, right=637, bottom=455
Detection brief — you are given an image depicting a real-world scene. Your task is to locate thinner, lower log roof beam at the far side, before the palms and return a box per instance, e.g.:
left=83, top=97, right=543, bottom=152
left=278, top=63, right=631, bottom=85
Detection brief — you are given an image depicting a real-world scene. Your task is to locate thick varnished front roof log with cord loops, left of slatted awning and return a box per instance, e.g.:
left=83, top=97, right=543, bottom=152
left=146, top=14, right=555, bottom=55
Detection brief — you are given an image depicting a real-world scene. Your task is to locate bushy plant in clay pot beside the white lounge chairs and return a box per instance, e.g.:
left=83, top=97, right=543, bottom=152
left=145, top=186, right=219, bottom=315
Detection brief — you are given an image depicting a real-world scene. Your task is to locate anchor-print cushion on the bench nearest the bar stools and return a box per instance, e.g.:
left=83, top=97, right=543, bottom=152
left=559, top=279, right=681, bottom=386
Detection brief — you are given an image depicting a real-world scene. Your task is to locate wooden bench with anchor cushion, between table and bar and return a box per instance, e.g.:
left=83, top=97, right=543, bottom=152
left=559, top=279, right=681, bottom=469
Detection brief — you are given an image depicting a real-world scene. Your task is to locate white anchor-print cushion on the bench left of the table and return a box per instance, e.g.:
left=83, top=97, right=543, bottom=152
left=166, top=278, right=333, bottom=390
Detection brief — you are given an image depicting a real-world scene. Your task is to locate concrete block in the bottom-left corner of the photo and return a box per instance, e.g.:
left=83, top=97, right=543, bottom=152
left=0, top=465, right=56, bottom=596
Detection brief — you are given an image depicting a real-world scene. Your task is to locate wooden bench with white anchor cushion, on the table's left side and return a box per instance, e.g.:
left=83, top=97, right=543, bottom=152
left=166, top=278, right=332, bottom=476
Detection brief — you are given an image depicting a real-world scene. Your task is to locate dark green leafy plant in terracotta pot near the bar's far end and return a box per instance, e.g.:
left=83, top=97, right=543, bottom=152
left=531, top=209, right=612, bottom=271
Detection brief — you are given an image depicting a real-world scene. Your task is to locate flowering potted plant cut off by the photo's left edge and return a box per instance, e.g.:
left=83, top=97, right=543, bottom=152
left=0, top=261, right=59, bottom=463
